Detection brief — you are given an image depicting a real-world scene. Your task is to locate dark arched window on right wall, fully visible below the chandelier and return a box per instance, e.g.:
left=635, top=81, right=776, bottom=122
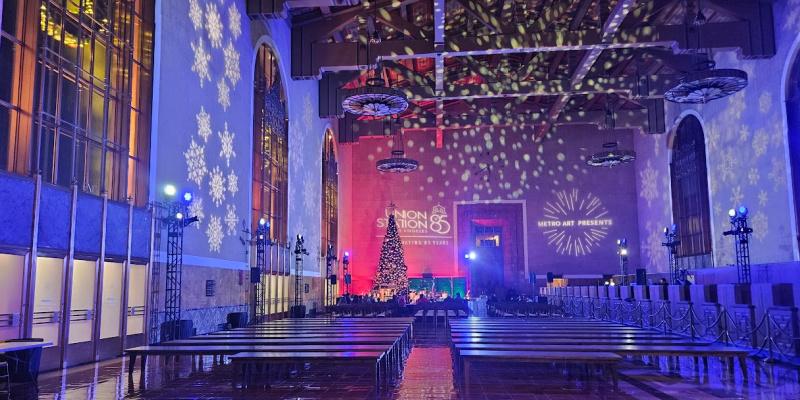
left=670, top=116, right=713, bottom=268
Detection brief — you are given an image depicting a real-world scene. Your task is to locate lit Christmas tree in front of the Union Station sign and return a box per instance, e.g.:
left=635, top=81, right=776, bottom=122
left=375, top=212, right=408, bottom=296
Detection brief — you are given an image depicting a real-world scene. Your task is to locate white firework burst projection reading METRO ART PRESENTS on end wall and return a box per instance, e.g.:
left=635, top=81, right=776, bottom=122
left=537, top=189, right=614, bottom=257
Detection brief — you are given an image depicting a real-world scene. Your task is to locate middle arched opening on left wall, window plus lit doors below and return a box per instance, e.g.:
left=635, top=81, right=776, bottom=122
left=251, top=44, right=290, bottom=316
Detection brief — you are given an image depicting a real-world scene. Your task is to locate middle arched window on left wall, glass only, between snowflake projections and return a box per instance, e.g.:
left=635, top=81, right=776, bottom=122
left=252, top=45, right=289, bottom=245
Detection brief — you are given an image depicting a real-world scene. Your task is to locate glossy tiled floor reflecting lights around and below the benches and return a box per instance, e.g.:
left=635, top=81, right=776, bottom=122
left=14, top=332, right=800, bottom=400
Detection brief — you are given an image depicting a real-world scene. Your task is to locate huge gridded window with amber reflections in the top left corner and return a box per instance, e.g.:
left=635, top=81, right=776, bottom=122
left=0, top=0, right=154, bottom=205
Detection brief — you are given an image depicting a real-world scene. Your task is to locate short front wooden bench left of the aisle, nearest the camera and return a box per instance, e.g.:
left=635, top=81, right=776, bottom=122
left=230, top=351, right=389, bottom=392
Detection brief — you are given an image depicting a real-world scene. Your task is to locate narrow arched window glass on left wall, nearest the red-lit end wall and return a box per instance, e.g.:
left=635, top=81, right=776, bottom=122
left=320, top=130, right=339, bottom=257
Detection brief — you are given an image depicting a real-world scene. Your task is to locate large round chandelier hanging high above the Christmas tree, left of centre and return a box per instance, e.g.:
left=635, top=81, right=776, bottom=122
left=342, top=78, right=408, bottom=117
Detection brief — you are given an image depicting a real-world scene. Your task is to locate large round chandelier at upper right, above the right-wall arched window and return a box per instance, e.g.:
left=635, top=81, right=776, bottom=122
left=664, top=69, right=747, bottom=104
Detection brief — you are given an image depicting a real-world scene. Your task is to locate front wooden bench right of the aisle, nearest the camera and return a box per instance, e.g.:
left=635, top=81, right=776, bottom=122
left=459, top=350, right=622, bottom=395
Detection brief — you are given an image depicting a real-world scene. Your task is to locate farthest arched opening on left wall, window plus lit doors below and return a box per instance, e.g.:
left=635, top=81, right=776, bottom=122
left=320, top=129, right=339, bottom=305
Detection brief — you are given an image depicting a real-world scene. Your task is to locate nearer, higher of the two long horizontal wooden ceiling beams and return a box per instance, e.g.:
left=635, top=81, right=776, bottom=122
left=292, top=21, right=775, bottom=78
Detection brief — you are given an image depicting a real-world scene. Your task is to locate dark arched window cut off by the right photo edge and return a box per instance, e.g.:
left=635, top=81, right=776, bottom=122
left=786, top=55, right=800, bottom=255
